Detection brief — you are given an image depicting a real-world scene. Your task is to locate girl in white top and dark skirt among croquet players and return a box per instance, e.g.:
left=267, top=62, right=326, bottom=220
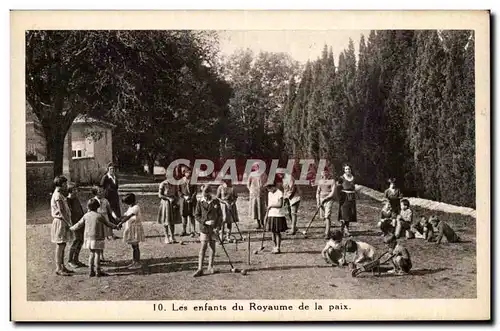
left=266, top=182, right=288, bottom=254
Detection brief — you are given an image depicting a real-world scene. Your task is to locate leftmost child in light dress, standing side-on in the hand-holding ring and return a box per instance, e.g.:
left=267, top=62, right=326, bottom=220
left=50, top=176, right=74, bottom=276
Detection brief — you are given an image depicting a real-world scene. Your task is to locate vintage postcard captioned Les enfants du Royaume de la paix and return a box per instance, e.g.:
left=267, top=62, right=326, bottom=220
left=10, top=11, right=491, bottom=322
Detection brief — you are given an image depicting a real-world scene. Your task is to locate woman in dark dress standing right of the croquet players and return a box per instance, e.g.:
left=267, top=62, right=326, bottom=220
left=339, top=163, right=357, bottom=236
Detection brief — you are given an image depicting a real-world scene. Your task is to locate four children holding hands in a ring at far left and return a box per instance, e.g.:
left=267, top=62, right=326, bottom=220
left=50, top=176, right=144, bottom=277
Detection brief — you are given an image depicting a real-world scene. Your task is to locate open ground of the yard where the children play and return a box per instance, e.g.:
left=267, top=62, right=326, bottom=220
left=26, top=189, right=476, bottom=301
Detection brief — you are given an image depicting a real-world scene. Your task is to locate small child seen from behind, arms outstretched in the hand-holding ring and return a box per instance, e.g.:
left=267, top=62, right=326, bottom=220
left=71, top=198, right=118, bottom=277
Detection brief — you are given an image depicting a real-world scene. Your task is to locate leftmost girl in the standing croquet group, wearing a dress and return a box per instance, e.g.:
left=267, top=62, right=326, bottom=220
left=156, top=175, right=182, bottom=244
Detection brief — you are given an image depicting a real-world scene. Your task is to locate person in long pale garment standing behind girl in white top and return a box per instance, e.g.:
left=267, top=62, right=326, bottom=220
left=247, top=163, right=267, bottom=229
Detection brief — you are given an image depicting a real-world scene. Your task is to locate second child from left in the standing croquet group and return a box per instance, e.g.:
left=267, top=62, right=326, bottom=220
left=179, top=168, right=196, bottom=238
